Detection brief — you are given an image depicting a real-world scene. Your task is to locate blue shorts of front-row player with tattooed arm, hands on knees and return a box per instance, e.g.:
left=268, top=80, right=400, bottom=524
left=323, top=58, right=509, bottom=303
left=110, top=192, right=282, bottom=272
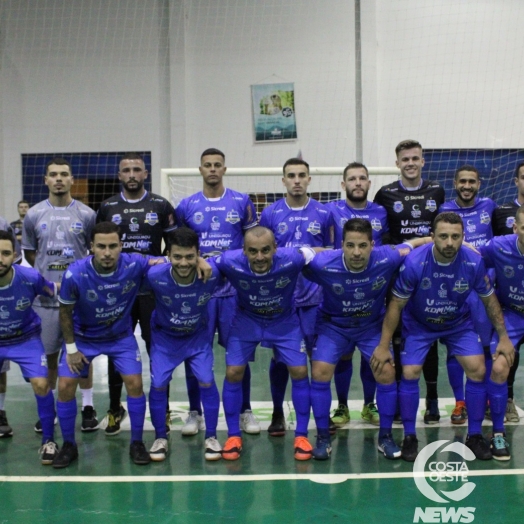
left=400, top=322, right=484, bottom=366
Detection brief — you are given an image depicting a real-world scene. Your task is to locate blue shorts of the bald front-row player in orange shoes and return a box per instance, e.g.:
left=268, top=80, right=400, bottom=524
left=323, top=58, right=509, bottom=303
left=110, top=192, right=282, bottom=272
left=226, top=313, right=307, bottom=366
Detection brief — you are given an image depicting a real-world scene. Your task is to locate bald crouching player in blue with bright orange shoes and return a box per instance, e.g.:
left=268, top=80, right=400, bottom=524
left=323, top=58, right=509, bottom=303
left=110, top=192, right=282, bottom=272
left=216, top=226, right=320, bottom=460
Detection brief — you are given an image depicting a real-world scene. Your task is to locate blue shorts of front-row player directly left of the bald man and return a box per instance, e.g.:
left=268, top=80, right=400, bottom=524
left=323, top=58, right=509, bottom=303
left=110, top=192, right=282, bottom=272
left=151, top=329, right=215, bottom=389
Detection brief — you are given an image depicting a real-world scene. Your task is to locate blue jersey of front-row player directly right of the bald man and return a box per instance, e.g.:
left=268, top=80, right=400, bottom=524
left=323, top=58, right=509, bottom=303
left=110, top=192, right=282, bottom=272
left=303, top=244, right=411, bottom=328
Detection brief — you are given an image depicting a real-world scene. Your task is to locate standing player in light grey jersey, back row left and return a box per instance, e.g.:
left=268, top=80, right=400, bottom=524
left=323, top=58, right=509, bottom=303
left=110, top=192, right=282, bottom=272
left=22, top=158, right=98, bottom=433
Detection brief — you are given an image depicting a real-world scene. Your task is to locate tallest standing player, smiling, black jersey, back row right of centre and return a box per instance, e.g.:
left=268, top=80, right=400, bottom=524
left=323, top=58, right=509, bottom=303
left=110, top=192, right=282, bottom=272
left=375, top=140, right=445, bottom=424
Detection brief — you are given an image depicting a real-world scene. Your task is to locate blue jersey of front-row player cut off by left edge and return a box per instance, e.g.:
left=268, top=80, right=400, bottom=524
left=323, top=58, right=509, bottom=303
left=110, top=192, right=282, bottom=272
left=0, top=265, right=55, bottom=346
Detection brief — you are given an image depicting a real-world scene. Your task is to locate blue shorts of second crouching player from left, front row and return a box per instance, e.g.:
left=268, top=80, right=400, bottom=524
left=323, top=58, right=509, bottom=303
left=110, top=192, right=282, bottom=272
left=58, top=335, right=142, bottom=378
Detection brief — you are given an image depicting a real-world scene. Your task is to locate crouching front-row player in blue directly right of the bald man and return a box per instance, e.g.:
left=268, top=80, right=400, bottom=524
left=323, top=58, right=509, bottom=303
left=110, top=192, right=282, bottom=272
left=304, top=218, right=426, bottom=460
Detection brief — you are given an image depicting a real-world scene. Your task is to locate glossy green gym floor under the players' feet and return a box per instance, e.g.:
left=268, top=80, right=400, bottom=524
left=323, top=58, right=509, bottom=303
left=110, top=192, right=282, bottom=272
left=0, top=336, right=524, bottom=524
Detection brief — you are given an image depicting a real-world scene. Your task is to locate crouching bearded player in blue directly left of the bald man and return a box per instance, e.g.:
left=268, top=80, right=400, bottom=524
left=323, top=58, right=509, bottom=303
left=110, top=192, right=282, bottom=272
left=147, top=227, right=222, bottom=461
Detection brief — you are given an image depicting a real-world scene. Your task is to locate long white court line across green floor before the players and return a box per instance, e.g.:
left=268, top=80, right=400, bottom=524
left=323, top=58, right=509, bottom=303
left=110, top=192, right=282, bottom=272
left=0, top=469, right=524, bottom=484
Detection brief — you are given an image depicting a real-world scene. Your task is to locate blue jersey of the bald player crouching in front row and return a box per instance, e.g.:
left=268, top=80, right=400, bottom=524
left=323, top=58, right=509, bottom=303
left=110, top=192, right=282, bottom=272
left=216, top=247, right=306, bottom=321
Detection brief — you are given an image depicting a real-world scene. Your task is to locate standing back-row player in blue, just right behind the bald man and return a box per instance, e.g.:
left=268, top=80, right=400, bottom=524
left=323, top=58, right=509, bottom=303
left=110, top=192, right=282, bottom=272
left=260, top=158, right=333, bottom=437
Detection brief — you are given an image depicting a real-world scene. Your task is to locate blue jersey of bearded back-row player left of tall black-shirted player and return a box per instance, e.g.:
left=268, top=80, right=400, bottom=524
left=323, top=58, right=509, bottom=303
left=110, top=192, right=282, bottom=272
left=326, top=200, right=389, bottom=249
